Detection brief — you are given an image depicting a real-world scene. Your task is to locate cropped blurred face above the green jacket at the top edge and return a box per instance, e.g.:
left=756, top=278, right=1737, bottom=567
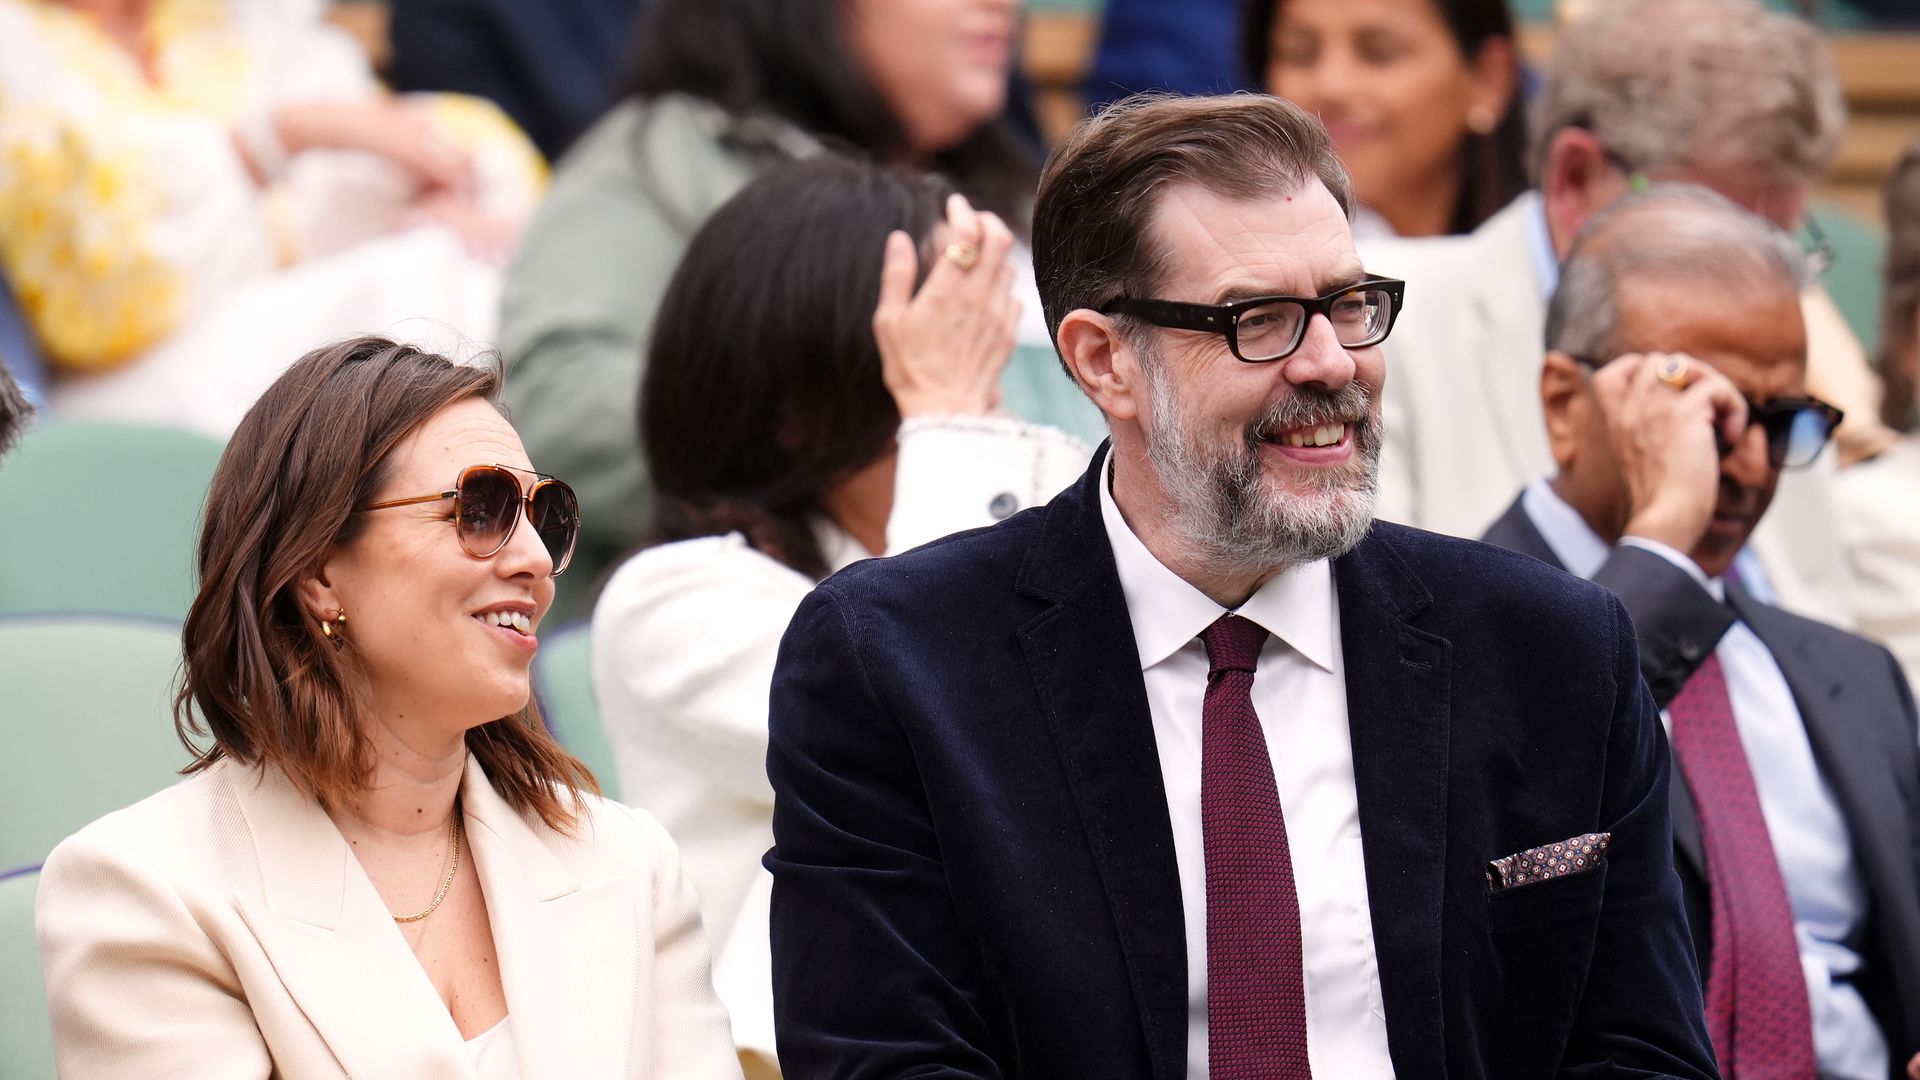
left=841, top=0, right=1020, bottom=154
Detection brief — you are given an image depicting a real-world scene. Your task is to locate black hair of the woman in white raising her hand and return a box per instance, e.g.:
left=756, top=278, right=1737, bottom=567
left=639, top=154, right=952, bottom=578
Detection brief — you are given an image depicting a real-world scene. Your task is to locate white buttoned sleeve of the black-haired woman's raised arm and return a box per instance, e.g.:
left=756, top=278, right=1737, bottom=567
left=887, top=417, right=1092, bottom=555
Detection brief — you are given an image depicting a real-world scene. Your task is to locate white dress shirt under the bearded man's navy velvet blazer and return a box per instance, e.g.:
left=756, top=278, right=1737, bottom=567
left=1100, top=455, right=1394, bottom=1080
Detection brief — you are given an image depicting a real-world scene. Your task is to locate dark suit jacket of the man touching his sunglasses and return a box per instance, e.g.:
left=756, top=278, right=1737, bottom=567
left=1486, top=502, right=1920, bottom=1078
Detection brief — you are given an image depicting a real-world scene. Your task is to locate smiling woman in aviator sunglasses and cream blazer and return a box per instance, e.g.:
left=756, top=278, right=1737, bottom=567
left=38, top=338, right=739, bottom=1080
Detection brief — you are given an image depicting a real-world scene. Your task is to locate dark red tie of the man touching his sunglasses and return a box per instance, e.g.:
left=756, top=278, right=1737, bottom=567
left=1668, top=655, right=1814, bottom=1080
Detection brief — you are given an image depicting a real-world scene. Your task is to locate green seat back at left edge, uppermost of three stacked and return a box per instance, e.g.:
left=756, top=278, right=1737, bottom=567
left=0, top=421, right=221, bottom=619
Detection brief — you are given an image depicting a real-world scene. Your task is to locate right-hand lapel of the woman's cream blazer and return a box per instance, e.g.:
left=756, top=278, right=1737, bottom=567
left=461, top=759, right=645, bottom=1080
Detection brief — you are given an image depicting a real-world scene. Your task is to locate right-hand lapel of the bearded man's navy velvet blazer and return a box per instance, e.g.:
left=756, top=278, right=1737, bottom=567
left=1334, top=534, right=1452, bottom=1076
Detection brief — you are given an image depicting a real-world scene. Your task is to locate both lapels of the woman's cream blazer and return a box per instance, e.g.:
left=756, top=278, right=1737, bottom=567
left=227, top=757, right=637, bottom=1080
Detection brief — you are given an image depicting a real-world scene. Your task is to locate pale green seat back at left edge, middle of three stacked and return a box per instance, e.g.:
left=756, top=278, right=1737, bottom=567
left=0, top=615, right=190, bottom=871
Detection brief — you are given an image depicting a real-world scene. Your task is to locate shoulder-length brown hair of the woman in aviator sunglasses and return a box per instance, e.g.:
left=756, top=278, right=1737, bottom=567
left=173, top=336, right=599, bottom=832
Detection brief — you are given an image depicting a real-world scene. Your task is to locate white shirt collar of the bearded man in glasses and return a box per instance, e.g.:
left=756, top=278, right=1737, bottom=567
left=1100, top=452, right=1340, bottom=675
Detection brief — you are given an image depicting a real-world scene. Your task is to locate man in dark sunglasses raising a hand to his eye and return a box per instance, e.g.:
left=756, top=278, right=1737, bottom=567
left=1486, top=186, right=1920, bottom=1080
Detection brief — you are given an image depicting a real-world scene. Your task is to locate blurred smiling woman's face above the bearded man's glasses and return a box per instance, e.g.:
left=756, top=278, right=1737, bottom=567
left=1265, top=0, right=1511, bottom=231
